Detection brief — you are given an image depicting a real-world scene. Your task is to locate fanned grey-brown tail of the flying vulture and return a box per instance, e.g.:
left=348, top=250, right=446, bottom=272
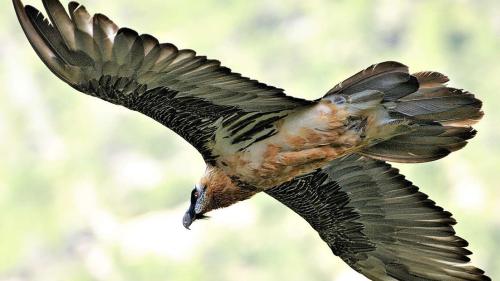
left=325, top=62, right=483, bottom=163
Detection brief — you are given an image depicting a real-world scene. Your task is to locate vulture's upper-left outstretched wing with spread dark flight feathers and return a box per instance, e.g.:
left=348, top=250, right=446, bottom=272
left=13, top=0, right=310, bottom=162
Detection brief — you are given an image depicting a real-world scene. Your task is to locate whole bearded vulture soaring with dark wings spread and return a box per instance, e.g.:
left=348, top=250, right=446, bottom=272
left=13, top=0, right=490, bottom=280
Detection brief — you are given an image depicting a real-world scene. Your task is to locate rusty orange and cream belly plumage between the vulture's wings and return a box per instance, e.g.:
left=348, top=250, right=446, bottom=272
left=219, top=101, right=361, bottom=190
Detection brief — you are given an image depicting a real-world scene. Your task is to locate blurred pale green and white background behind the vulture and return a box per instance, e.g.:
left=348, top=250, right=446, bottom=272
left=0, top=0, right=500, bottom=281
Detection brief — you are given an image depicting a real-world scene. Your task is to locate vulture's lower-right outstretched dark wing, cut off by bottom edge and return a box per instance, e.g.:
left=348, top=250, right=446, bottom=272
left=266, top=155, right=490, bottom=280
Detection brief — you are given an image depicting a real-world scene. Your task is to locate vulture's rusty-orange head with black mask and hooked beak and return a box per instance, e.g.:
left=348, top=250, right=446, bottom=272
left=182, top=166, right=257, bottom=229
